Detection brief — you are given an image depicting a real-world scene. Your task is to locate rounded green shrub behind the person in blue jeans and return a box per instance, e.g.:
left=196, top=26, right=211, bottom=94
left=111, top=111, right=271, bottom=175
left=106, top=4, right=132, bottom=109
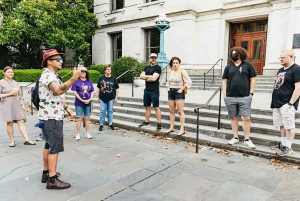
left=112, top=57, right=139, bottom=83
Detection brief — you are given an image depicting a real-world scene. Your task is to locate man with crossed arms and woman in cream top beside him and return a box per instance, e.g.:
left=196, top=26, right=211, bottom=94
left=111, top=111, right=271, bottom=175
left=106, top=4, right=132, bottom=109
left=139, top=53, right=192, bottom=136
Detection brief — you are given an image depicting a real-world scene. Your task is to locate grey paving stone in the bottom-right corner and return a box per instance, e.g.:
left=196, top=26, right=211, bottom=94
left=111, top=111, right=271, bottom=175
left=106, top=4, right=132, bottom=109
left=271, top=174, right=300, bottom=201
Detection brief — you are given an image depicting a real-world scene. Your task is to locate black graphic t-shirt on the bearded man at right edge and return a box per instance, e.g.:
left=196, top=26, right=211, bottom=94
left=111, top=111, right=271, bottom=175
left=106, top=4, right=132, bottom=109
left=271, top=64, right=300, bottom=110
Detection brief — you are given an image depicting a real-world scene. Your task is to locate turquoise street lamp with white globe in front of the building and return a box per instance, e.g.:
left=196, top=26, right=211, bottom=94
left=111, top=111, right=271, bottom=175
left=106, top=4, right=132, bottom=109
left=155, top=13, right=170, bottom=67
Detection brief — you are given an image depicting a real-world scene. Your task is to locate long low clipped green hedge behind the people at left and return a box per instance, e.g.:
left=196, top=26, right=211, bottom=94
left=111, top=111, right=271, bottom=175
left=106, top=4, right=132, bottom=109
left=0, top=69, right=100, bottom=83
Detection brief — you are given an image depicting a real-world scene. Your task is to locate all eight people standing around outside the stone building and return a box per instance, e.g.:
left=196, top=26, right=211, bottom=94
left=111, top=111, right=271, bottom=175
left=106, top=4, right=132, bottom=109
left=0, top=47, right=300, bottom=189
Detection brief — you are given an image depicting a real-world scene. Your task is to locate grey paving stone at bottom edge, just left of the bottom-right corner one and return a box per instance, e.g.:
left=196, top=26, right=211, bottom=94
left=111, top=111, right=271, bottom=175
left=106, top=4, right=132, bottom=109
left=202, top=180, right=271, bottom=201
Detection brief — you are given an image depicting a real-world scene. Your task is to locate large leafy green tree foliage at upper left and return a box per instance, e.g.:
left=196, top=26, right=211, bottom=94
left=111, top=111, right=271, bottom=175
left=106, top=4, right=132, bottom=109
left=0, top=0, right=98, bottom=65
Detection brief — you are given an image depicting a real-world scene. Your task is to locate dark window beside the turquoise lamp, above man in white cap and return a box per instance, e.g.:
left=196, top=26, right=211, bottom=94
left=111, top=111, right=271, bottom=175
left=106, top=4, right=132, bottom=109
left=146, top=29, right=160, bottom=60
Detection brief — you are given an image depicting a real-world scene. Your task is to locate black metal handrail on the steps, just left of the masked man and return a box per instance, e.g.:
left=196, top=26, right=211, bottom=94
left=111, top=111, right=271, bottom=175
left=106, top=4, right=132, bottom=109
left=194, top=85, right=222, bottom=153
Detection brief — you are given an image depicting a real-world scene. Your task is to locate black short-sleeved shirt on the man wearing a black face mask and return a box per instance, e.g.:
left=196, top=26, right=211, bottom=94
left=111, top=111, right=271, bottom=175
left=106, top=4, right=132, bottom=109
left=222, top=61, right=256, bottom=97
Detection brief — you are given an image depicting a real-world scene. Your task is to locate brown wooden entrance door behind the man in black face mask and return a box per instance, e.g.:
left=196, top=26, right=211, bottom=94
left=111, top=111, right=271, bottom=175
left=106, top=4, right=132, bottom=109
left=230, top=21, right=267, bottom=75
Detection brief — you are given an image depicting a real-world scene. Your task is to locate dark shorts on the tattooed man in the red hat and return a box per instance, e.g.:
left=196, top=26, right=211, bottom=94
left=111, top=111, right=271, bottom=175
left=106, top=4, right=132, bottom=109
left=43, top=119, right=64, bottom=154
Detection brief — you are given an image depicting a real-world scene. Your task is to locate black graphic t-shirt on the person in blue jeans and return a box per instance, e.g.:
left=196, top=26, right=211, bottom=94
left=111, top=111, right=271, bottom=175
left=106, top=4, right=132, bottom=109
left=97, top=75, right=119, bottom=102
